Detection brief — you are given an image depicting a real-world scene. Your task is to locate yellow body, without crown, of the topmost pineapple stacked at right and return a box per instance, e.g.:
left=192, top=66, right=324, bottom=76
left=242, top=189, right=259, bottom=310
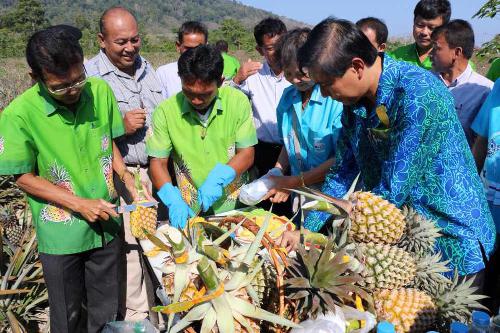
left=349, top=192, right=405, bottom=244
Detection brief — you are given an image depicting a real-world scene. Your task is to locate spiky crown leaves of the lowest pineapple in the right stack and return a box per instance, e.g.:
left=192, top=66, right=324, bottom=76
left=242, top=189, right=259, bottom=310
left=431, top=270, right=487, bottom=322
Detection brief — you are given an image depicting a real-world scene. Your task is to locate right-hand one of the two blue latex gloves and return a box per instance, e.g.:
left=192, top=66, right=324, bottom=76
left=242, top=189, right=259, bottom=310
left=198, top=163, right=236, bottom=212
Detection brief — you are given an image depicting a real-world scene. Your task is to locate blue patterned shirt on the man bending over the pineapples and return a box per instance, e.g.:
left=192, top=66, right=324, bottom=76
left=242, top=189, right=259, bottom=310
left=304, top=56, right=495, bottom=275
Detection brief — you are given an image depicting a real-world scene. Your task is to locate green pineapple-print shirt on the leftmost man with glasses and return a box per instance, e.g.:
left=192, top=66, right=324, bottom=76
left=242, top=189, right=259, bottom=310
left=0, top=78, right=124, bottom=254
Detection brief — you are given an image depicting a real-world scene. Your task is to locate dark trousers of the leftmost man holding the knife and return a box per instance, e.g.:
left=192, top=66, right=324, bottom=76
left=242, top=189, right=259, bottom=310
left=40, top=237, right=122, bottom=333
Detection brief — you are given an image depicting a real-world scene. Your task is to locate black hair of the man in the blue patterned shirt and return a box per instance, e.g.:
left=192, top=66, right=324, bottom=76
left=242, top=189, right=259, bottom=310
left=298, top=17, right=377, bottom=77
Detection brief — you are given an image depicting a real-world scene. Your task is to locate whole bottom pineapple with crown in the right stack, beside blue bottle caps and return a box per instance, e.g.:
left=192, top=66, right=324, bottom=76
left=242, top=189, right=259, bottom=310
left=373, top=274, right=485, bottom=333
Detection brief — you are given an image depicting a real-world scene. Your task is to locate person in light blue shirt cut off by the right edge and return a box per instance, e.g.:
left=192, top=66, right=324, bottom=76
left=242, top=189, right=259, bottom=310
left=472, top=80, right=500, bottom=313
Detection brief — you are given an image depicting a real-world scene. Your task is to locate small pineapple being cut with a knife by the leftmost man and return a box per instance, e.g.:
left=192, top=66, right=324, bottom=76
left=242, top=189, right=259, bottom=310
left=130, top=167, right=158, bottom=239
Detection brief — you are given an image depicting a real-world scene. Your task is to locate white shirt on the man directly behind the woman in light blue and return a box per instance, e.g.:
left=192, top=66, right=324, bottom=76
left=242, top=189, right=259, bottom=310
left=231, top=62, right=291, bottom=143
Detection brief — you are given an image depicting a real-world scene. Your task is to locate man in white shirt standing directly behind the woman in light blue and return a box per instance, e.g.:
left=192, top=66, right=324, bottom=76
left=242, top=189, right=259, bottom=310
left=231, top=17, right=290, bottom=176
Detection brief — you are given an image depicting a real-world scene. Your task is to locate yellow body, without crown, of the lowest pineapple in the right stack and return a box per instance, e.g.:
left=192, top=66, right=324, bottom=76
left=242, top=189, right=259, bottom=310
left=373, top=288, right=437, bottom=333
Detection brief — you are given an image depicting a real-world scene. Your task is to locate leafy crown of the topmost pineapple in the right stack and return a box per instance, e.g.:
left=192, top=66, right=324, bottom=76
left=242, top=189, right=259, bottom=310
left=398, top=207, right=441, bottom=254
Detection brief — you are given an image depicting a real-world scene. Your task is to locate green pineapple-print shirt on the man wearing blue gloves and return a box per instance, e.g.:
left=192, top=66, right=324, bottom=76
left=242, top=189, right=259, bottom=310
left=146, top=87, right=257, bottom=213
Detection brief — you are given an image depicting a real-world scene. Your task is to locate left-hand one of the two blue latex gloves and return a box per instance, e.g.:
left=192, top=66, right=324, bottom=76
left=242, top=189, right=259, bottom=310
left=158, top=183, right=195, bottom=228
